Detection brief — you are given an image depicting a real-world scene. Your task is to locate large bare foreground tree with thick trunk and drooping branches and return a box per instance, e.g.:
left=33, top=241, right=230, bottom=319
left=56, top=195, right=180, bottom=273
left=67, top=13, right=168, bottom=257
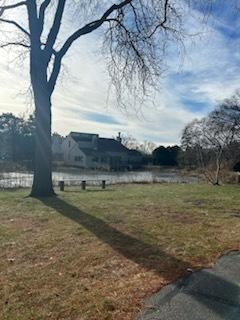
left=0, top=0, right=187, bottom=196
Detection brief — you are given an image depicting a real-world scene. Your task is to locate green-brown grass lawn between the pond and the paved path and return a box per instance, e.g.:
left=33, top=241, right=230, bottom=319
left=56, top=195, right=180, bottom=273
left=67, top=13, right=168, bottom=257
left=0, top=184, right=240, bottom=320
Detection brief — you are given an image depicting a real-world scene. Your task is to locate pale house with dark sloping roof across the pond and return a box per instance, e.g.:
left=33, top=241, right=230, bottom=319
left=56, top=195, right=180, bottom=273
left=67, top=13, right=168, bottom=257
left=63, top=132, right=142, bottom=170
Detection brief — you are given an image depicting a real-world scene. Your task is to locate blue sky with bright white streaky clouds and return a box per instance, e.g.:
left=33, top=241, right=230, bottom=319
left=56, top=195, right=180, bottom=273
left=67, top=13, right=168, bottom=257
left=0, top=0, right=240, bottom=145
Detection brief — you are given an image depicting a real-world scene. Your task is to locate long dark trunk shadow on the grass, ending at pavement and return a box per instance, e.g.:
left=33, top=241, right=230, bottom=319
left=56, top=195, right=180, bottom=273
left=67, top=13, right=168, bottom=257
left=39, top=197, right=191, bottom=280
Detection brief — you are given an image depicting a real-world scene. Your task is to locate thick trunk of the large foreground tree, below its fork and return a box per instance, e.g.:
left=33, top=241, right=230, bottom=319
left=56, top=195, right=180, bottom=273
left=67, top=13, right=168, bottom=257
left=30, top=83, right=55, bottom=197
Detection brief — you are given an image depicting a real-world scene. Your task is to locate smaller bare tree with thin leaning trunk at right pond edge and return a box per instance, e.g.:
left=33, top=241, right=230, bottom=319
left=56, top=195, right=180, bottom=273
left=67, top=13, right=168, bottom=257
left=182, top=109, right=239, bottom=185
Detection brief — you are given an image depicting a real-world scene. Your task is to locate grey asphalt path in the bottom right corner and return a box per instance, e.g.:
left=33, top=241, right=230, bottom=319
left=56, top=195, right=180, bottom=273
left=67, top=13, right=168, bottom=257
left=138, top=252, right=240, bottom=320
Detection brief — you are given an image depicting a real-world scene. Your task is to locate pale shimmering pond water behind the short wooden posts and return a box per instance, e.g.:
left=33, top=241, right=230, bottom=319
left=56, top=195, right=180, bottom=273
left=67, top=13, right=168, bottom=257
left=0, top=170, right=199, bottom=188
